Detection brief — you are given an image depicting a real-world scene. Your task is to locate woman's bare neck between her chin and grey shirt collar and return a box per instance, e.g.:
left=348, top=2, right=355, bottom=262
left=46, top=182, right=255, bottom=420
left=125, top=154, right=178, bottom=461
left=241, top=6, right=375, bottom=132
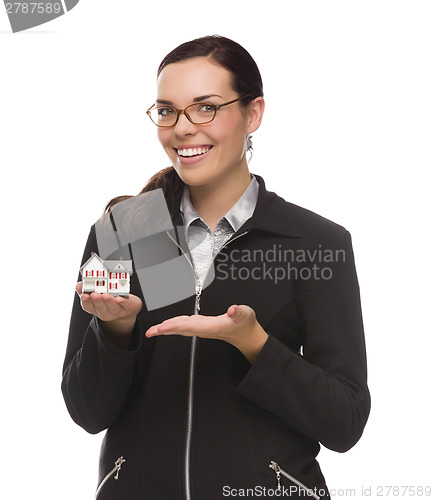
left=188, top=166, right=251, bottom=232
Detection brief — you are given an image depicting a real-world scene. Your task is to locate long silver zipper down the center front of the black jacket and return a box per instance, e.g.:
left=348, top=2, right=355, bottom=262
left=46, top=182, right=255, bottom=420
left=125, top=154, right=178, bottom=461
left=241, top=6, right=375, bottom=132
left=167, top=231, right=248, bottom=500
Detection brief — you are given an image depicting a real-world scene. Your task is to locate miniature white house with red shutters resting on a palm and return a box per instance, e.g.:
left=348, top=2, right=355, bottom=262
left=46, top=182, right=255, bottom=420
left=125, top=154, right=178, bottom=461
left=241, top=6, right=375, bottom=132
left=80, top=253, right=132, bottom=296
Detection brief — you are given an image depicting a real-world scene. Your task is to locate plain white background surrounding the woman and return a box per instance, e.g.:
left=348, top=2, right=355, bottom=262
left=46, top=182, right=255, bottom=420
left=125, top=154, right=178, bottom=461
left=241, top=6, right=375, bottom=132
left=0, top=0, right=433, bottom=500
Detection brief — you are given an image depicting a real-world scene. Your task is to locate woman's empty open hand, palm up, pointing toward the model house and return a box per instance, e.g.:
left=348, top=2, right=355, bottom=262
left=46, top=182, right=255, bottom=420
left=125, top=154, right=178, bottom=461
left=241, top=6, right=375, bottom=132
left=146, top=305, right=268, bottom=364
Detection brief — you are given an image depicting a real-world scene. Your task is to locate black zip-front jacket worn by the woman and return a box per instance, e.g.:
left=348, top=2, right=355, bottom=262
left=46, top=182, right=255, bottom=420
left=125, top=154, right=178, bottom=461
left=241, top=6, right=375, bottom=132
left=62, top=175, right=370, bottom=500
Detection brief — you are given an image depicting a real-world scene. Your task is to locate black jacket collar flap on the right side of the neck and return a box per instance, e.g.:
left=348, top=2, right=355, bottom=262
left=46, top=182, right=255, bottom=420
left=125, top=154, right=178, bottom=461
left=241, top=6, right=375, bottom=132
left=173, top=174, right=301, bottom=238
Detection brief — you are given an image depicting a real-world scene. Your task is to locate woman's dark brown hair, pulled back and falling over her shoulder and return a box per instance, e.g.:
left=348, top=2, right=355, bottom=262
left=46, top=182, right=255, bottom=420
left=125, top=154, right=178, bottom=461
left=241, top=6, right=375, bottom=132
left=105, top=35, right=263, bottom=218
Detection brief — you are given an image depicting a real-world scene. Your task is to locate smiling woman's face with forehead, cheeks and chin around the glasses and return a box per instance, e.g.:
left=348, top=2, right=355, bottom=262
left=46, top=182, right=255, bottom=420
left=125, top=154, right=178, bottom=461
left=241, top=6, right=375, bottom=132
left=157, top=57, right=258, bottom=186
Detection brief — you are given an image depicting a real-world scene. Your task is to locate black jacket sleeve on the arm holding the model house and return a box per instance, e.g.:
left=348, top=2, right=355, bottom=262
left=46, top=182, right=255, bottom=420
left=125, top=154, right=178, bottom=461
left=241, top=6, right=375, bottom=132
left=62, top=226, right=142, bottom=434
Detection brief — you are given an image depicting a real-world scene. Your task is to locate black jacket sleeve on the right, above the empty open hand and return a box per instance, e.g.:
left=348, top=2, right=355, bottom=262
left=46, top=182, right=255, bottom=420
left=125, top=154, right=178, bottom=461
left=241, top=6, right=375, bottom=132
left=235, top=230, right=370, bottom=452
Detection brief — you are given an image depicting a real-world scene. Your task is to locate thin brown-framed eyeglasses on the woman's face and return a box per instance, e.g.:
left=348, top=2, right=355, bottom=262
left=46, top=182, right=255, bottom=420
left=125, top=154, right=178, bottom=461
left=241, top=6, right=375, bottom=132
left=146, top=94, right=253, bottom=127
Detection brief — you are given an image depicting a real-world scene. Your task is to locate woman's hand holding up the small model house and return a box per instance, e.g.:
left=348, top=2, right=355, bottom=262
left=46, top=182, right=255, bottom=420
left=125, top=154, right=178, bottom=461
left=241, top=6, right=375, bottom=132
left=75, top=281, right=143, bottom=349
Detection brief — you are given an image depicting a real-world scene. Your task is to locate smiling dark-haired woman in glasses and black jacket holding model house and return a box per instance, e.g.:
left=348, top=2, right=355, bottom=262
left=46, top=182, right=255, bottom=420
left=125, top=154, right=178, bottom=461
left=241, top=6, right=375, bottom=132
left=62, top=36, right=370, bottom=500
